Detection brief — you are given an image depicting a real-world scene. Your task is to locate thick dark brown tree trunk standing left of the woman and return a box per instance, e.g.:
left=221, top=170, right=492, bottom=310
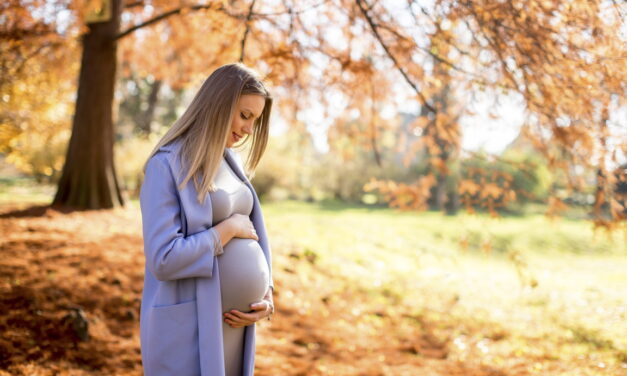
left=52, top=0, right=124, bottom=209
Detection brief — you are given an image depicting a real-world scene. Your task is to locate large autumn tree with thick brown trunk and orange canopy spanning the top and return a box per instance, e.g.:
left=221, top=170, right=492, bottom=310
left=3, top=0, right=627, bottom=229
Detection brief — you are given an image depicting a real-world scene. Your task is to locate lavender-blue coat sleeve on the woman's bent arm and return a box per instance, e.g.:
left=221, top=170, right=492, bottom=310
left=139, top=154, right=222, bottom=281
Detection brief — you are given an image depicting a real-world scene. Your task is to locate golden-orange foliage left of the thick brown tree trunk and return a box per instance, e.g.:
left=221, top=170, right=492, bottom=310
left=0, top=0, right=78, bottom=182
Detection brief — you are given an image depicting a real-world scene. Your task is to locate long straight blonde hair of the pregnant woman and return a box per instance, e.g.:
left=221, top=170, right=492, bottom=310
left=143, top=62, right=272, bottom=203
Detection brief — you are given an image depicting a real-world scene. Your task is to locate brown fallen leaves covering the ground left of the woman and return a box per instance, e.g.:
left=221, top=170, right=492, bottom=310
left=0, top=207, right=143, bottom=374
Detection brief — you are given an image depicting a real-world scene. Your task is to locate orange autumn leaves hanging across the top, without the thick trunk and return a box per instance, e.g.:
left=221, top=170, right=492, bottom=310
left=3, top=0, right=627, bottom=227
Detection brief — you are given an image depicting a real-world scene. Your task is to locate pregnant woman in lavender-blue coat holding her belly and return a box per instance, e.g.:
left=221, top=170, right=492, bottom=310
left=140, top=63, right=274, bottom=376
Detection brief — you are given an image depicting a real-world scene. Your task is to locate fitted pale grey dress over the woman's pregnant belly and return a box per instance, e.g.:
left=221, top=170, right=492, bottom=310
left=209, top=153, right=270, bottom=376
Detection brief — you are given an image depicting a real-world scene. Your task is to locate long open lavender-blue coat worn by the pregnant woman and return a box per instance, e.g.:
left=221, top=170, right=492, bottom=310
left=139, top=139, right=273, bottom=376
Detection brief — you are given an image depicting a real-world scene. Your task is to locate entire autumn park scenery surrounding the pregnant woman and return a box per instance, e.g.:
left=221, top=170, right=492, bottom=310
left=0, top=0, right=627, bottom=376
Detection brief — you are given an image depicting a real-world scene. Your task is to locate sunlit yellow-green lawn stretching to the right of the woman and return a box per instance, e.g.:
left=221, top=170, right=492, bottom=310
left=263, top=201, right=627, bottom=361
